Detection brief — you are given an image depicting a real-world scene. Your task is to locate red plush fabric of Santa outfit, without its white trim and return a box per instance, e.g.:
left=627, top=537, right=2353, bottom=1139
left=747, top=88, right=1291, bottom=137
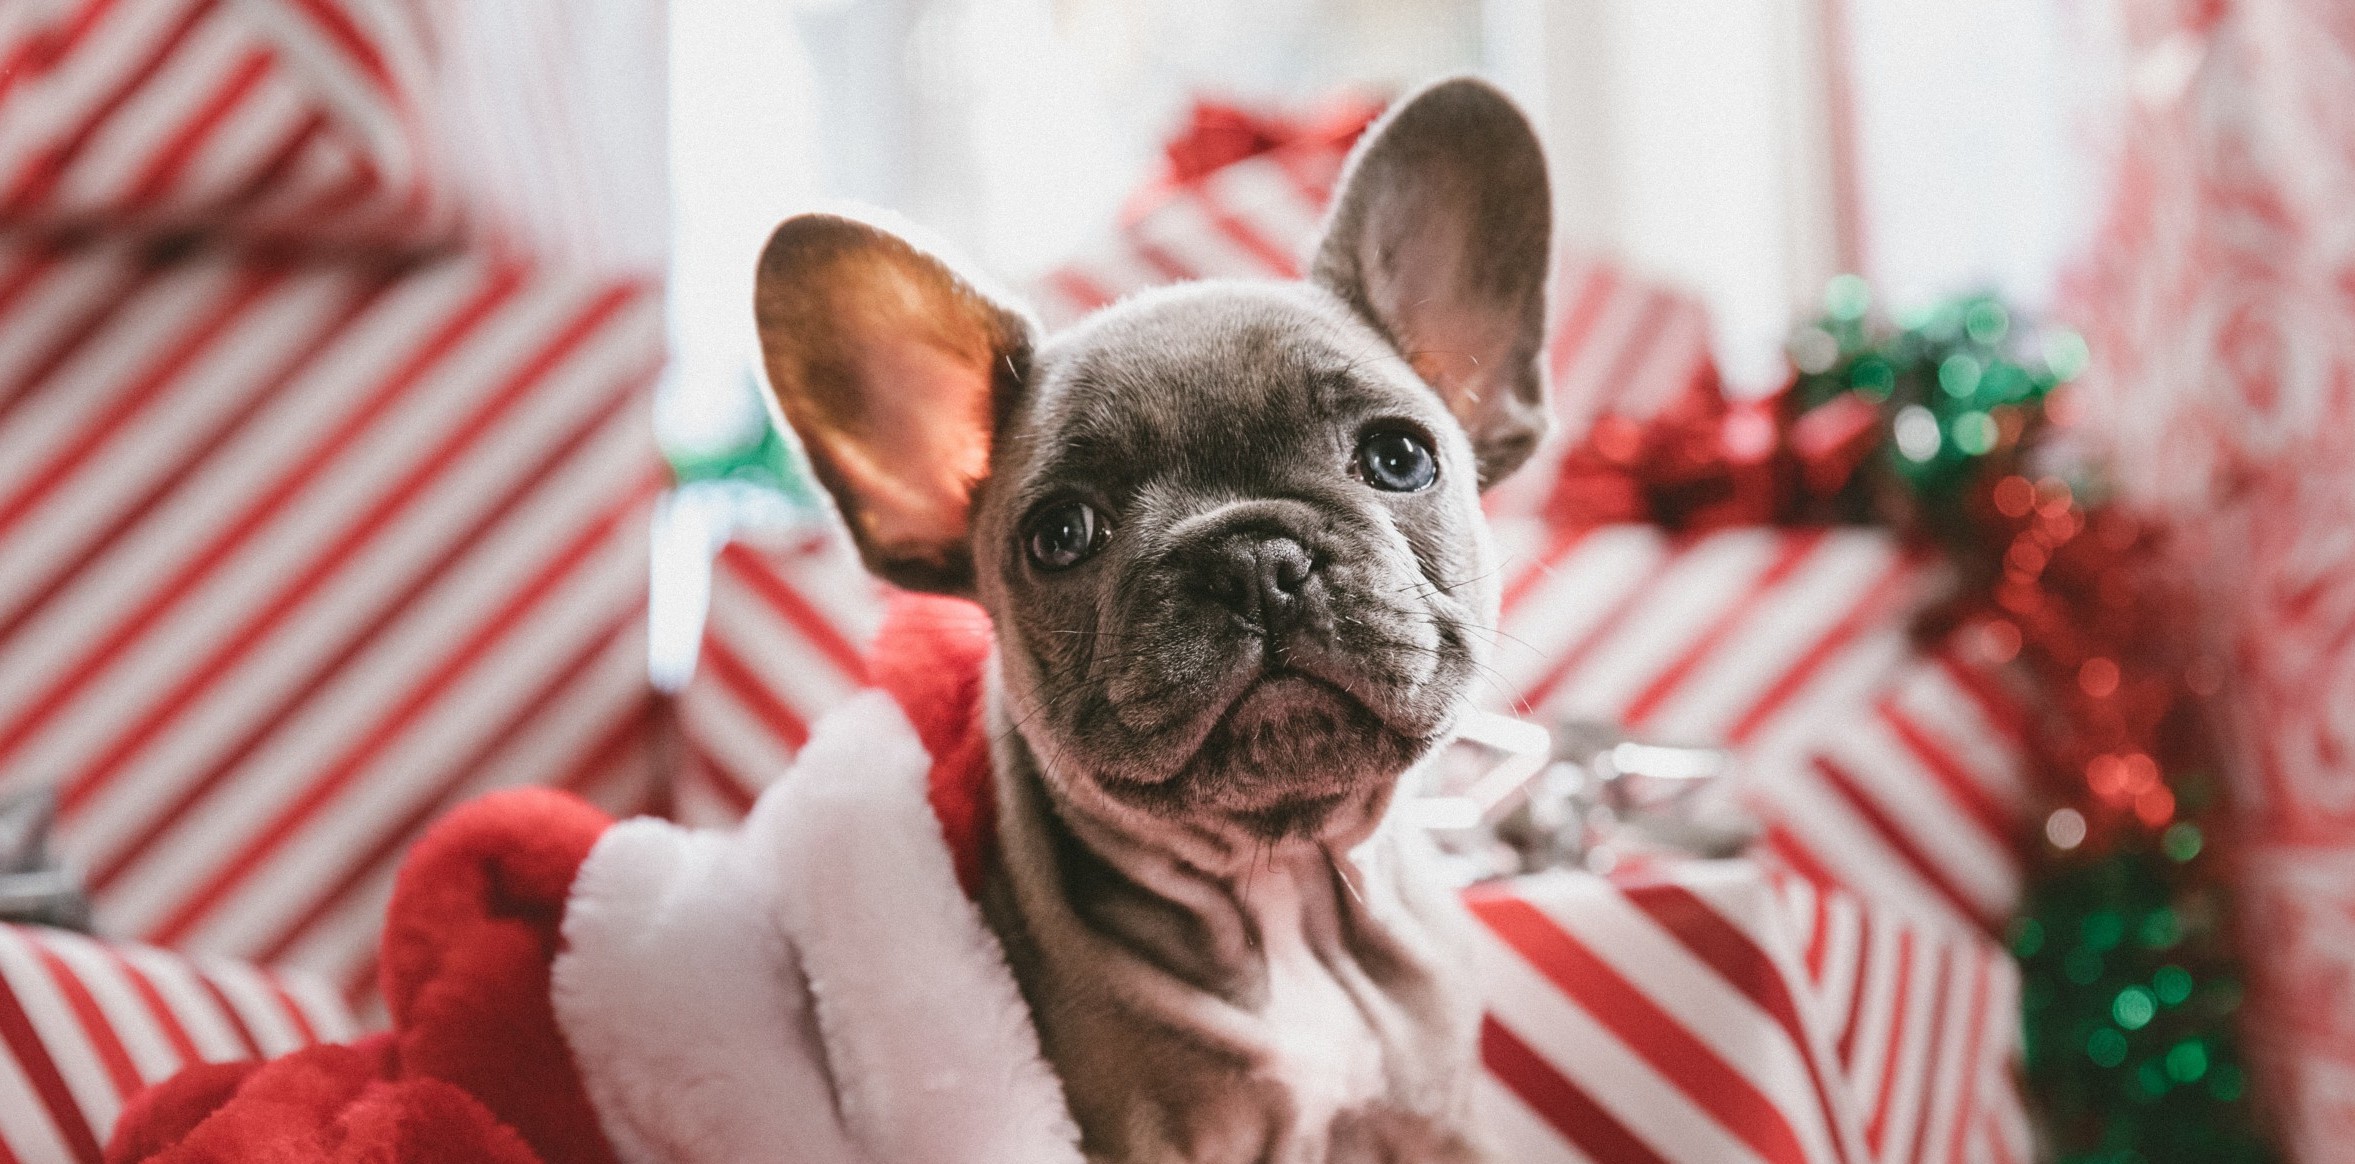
left=106, top=596, right=996, bottom=1164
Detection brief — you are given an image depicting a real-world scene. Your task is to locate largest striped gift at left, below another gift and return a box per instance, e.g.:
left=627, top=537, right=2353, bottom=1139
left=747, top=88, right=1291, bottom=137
left=0, top=236, right=669, bottom=994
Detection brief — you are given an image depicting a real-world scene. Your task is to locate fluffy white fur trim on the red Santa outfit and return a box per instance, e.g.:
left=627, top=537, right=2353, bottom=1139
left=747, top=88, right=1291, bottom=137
left=553, top=693, right=1081, bottom=1164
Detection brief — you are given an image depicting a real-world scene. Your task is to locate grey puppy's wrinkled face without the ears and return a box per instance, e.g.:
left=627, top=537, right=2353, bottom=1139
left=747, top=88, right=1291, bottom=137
left=973, top=285, right=1495, bottom=839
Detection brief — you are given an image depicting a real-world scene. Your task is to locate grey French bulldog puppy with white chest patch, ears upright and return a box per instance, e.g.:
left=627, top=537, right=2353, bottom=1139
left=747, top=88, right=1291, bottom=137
left=756, top=80, right=1550, bottom=1164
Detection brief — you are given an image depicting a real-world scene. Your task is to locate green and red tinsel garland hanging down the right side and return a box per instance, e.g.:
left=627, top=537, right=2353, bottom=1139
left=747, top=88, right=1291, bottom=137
left=1783, top=278, right=2275, bottom=1164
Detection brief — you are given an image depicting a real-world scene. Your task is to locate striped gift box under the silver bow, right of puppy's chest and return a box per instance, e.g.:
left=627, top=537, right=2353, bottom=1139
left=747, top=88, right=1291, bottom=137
left=1467, top=860, right=2030, bottom=1164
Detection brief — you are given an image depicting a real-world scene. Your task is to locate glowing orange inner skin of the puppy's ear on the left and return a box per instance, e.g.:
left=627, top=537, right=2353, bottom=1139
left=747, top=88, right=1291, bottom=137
left=834, top=328, right=991, bottom=558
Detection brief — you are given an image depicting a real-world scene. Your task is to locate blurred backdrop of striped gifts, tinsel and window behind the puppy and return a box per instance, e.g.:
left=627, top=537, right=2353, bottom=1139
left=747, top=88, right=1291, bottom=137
left=0, top=0, right=2355, bottom=1164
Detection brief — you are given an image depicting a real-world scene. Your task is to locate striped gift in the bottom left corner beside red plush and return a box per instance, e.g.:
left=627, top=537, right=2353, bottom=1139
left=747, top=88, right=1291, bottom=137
left=0, top=926, right=358, bottom=1164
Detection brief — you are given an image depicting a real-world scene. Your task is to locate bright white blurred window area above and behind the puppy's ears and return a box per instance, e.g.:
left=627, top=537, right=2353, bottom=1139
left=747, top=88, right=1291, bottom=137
left=664, top=0, right=2127, bottom=454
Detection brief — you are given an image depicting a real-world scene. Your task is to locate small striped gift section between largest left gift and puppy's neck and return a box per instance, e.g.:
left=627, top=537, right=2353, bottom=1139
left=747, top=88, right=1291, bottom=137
left=671, top=523, right=883, bottom=825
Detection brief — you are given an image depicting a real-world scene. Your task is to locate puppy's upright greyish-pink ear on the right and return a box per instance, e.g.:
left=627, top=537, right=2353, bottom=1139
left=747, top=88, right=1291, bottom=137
left=1312, top=78, right=1552, bottom=488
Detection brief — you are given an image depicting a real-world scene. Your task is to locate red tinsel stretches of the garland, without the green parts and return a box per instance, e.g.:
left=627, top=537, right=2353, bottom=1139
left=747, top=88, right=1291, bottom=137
left=1547, top=367, right=2216, bottom=851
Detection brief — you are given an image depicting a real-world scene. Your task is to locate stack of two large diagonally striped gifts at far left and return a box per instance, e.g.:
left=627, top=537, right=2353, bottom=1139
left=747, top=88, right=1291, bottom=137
left=0, top=0, right=669, bottom=1041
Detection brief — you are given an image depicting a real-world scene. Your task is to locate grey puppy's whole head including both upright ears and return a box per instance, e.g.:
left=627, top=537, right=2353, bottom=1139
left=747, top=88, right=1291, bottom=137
left=756, top=80, right=1547, bottom=841
